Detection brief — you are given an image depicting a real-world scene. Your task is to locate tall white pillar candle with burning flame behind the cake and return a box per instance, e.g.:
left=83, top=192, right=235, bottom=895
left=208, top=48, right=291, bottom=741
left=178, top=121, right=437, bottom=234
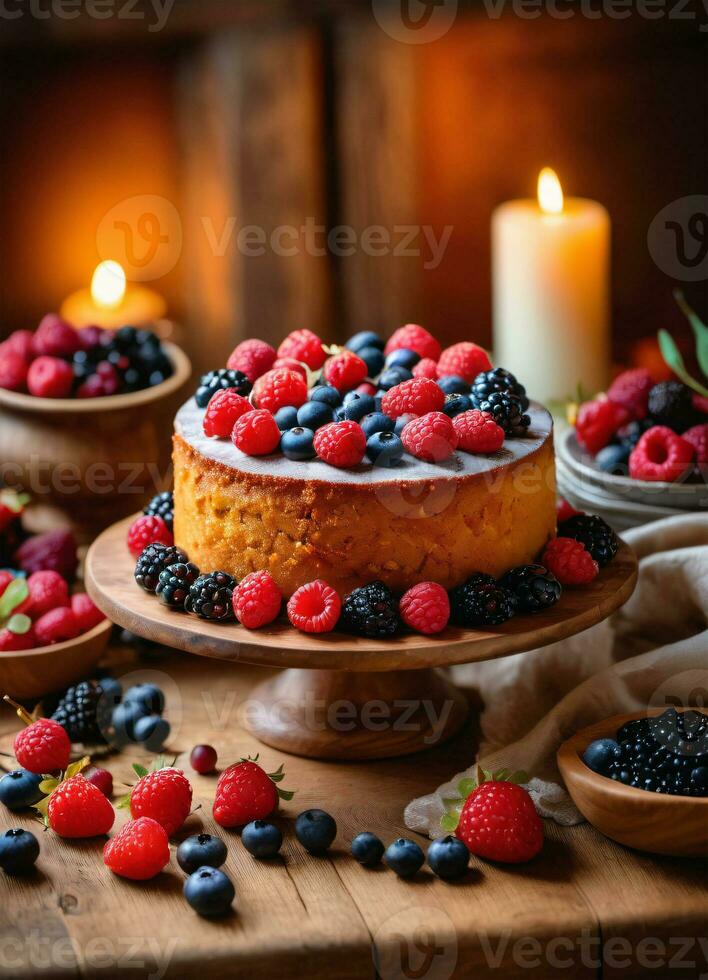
left=492, top=168, right=610, bottom=402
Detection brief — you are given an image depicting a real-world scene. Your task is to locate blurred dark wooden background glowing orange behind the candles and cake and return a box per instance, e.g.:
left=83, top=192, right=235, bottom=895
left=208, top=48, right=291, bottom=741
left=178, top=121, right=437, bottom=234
left=0, top=0, right=708, bottom=378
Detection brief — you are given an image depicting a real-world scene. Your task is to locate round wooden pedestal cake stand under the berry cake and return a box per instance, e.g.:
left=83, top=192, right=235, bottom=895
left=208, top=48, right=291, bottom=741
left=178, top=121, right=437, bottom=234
left=85, top=518, right=637, bottom=759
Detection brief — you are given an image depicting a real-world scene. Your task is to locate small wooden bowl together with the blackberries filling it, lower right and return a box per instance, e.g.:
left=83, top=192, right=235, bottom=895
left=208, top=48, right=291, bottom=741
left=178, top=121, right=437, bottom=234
left=558, top=707, right=708, bottom=856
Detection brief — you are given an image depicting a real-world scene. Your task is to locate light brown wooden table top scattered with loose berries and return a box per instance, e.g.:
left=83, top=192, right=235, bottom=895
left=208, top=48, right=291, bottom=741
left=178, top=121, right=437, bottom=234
left=0, top=647, right=708, bottom=980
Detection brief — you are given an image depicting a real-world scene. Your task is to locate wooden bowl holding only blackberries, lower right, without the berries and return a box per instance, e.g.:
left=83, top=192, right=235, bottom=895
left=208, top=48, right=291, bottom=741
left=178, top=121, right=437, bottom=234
left=557, top=708, right=708, bottom=857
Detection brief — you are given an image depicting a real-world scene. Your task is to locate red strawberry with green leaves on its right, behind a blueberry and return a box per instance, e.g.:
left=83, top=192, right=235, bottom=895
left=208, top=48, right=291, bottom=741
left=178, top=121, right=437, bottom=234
left=214, top=756, right=293, bottom=827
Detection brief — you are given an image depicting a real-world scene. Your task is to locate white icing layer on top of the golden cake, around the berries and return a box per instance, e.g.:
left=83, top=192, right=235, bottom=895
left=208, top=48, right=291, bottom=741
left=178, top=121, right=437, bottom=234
left=175, top=398, right=553, bottom=486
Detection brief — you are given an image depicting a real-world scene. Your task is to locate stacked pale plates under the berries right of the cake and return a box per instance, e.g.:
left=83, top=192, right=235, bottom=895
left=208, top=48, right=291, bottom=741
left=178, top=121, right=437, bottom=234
left=556, top=429, right=708, bottom=531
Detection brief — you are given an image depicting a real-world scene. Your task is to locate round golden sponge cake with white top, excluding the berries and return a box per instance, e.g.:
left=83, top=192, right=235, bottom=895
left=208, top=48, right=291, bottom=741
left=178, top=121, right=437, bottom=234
left=173, top=399, right=556, bottom=596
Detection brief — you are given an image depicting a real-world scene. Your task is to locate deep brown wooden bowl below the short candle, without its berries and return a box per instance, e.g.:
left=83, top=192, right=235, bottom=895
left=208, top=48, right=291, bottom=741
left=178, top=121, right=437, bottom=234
left=0, top=341, right=191, bottom=543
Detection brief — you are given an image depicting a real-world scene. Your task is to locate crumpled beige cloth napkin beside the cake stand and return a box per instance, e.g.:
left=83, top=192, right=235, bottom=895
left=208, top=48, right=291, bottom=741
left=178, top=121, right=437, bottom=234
left=405, top=513, right=708, bottom=837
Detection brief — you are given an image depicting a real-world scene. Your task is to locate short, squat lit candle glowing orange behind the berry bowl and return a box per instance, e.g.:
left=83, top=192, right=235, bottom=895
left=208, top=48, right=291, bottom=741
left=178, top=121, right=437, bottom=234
left=61, top=259, right=167, bottom=329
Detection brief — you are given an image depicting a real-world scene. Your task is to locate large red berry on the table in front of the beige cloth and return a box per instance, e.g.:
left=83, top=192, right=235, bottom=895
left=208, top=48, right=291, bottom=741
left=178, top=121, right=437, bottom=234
left=455, top=781, right=543, bottom=864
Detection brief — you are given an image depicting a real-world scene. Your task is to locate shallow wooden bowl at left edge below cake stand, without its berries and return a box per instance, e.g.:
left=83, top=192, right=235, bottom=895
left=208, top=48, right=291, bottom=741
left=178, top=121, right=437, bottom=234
left=0, top=619, right=113, bottom=701
